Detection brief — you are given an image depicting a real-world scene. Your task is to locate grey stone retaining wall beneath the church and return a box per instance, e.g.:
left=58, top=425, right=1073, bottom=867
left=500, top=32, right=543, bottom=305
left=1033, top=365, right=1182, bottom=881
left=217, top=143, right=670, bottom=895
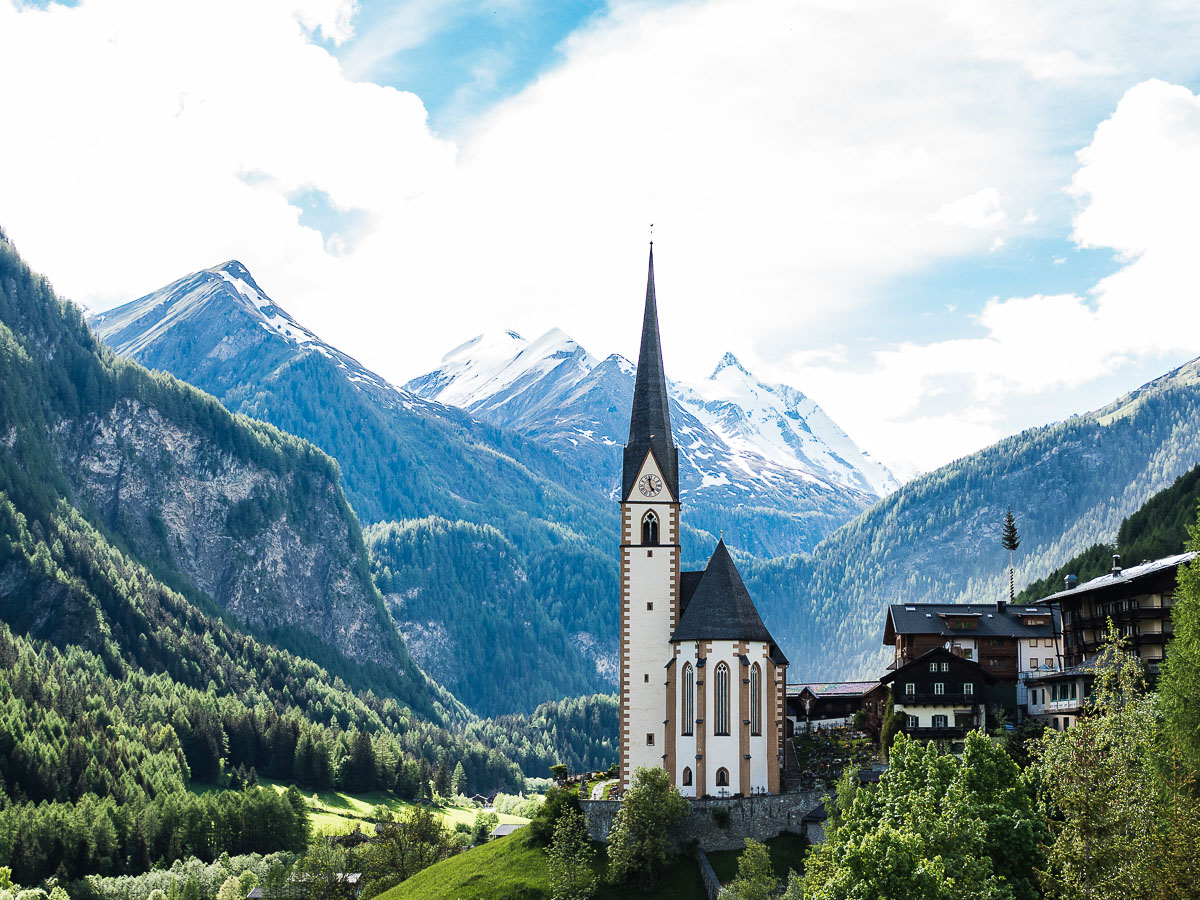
left=580, top=790, right=827, bottom=853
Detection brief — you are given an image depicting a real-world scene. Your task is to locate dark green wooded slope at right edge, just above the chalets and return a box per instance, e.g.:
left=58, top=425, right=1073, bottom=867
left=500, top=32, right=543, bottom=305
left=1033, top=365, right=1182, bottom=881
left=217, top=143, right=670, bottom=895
left=1016, top=466, right=1200, bottom=604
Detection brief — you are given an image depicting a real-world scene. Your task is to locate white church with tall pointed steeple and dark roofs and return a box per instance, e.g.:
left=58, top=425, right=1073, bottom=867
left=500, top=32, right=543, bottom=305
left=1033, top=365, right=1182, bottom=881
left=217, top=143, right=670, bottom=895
left=620, top=244, right=787, bottom=797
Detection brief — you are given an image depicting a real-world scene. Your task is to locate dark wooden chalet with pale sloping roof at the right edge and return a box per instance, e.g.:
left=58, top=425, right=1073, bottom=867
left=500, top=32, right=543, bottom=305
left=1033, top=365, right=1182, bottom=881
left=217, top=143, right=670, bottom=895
left=1037, top=552, right=1196, bottom=678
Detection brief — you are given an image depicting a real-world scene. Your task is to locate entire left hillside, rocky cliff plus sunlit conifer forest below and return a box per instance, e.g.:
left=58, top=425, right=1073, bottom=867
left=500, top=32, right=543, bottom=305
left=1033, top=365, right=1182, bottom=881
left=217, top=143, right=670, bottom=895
left=0, top=233, right=611, bottom=883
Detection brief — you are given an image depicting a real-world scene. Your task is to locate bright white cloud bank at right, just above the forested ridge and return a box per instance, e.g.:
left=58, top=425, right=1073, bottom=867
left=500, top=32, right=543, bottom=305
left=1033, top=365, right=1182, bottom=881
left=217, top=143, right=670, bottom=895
left=788, top=80, right=1200, bottom=468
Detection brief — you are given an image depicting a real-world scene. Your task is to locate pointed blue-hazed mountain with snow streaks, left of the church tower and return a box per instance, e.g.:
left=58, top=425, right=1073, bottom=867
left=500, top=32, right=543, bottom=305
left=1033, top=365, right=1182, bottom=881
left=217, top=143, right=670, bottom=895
left=91, top=262, right=619, bottom=714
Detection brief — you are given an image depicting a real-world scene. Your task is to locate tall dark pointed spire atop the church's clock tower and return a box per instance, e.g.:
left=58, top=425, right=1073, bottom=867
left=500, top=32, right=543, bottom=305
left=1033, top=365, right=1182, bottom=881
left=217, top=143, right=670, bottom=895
left=622, top=247, right=679, bottom=500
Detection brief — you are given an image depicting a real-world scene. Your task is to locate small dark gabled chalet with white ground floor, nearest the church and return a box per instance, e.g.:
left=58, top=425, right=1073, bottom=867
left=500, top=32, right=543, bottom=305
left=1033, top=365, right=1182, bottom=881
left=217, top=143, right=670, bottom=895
left=880, top=647, right=996, bottom=750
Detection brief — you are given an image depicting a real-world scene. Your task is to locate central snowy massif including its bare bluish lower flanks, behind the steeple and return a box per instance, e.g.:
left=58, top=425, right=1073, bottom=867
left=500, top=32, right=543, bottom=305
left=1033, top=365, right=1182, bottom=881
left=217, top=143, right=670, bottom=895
left=404, top=329, right=899, bottom=556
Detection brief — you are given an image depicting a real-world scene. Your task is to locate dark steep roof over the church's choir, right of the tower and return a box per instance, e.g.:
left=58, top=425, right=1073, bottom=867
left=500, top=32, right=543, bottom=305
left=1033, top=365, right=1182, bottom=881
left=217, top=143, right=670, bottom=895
left=671, top=540, right=787, bottom=664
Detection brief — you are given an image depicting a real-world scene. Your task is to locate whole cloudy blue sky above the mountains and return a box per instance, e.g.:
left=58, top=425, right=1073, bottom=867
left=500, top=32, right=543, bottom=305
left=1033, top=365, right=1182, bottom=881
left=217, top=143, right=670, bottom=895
left=0, top=0, right=1200, bottom=472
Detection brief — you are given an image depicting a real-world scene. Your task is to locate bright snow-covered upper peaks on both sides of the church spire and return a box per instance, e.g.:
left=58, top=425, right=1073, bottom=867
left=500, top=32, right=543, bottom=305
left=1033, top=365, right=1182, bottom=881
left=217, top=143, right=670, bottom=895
left=407, top=329, right=898, bottom=535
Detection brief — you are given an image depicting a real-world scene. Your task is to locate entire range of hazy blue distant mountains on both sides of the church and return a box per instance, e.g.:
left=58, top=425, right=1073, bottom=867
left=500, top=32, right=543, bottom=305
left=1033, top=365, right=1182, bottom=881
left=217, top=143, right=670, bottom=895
left=92, top=263, right=1200, bottom=696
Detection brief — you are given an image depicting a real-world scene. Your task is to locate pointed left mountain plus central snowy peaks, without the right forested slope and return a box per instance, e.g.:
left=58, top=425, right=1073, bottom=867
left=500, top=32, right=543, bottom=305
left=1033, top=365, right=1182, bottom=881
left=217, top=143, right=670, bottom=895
left=91, top=262, right=896, bottom=714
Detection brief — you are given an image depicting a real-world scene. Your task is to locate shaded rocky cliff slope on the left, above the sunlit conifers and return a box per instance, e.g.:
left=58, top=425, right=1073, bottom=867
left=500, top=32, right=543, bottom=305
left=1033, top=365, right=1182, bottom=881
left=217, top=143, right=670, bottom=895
left=0, top=241, right=436, bottom=718
